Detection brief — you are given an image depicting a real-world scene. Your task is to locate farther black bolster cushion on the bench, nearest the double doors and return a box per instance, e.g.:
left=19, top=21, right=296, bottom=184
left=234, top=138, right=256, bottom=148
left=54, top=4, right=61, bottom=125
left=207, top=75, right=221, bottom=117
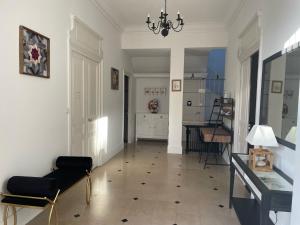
left=56, top=156, right=93, bottom=171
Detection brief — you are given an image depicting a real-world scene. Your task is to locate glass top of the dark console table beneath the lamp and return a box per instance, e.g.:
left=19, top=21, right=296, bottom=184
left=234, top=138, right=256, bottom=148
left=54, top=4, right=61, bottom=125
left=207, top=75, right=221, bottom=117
left=238, top=154, right=293, bottom=191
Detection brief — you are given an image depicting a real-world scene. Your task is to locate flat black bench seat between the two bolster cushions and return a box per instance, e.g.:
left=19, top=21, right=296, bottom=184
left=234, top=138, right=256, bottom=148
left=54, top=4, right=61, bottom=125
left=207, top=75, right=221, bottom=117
left=45, top=169, right=86, bottom=193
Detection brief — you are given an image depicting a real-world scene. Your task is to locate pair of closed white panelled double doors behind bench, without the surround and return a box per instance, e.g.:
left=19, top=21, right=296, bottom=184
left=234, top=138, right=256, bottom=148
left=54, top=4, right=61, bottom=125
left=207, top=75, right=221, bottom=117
left=71, top=51, right=100, bottom=165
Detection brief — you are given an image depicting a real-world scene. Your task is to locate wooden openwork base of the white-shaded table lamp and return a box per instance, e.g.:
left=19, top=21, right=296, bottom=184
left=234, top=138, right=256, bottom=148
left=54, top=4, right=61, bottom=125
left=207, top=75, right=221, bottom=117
left=249, top=148, right=274, bottom=172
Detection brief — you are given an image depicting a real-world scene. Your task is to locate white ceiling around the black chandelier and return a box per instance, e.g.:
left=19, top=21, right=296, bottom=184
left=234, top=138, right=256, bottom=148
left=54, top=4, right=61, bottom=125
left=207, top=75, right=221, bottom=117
left=96, top=0, right=243, bottom=29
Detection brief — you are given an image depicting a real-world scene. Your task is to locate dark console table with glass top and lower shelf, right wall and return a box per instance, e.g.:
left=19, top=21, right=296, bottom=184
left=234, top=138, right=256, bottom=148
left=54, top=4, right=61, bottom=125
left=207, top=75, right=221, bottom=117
left=229, top=154, right=293, bottom=225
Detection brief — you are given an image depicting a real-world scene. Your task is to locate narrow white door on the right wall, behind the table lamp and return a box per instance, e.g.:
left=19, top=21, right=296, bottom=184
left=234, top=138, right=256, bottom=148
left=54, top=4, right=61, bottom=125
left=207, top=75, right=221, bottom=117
left=237, top=58, right=251, bottom=153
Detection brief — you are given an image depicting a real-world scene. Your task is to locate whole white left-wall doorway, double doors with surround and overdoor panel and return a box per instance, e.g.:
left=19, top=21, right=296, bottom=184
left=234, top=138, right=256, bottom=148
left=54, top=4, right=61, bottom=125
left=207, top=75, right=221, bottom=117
left=69, top=17, right=102, bottom=167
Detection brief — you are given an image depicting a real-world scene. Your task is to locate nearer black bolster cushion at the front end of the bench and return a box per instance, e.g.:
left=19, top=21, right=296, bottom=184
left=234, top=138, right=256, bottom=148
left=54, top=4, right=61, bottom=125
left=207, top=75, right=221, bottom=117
left=7, top=176, right=58, bottom=199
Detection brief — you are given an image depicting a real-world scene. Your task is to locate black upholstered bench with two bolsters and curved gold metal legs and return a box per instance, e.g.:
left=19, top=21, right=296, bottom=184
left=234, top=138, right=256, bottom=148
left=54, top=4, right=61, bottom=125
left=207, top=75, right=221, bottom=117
left=0, top=156, right=93, bottom=225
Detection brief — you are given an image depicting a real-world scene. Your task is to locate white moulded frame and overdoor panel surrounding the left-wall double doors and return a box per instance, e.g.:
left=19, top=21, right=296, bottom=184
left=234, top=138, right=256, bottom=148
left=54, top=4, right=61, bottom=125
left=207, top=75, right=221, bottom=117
left=67, top=15, right=103, bottom=167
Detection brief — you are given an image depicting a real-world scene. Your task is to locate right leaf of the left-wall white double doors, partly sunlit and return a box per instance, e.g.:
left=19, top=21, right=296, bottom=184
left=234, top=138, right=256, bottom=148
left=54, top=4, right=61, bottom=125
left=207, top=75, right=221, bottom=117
left=85, top=59, right=100, bottom=164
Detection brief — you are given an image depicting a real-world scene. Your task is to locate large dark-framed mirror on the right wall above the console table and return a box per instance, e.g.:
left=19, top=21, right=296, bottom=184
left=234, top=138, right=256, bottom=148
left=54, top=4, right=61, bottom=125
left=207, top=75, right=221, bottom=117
left=260, top=49, right=300, bottom=149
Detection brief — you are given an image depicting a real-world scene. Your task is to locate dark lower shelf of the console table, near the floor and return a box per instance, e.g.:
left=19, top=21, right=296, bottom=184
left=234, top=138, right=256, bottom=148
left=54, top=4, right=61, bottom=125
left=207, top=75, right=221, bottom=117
left=232, top=198, right=274, bottom=225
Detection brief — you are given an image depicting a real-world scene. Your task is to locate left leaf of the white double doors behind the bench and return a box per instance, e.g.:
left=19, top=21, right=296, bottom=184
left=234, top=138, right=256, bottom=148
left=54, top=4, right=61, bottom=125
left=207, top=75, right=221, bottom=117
left=71, top=52, right=86, bottom=156
